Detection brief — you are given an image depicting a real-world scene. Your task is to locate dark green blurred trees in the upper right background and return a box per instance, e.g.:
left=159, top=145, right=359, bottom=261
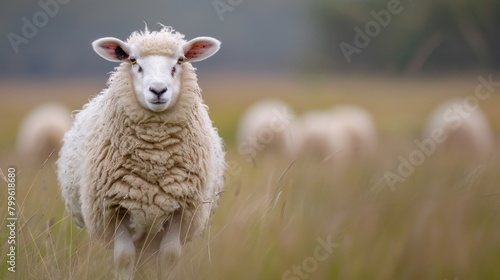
left=309, top=0, right=500, bottom=73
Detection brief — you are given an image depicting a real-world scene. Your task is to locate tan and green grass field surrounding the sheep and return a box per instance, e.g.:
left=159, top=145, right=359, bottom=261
left=0, top=75, right=500, bottom=280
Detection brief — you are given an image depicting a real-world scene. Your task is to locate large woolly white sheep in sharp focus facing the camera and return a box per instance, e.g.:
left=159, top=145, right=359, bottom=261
left=57, top=26, right=226, bottom=279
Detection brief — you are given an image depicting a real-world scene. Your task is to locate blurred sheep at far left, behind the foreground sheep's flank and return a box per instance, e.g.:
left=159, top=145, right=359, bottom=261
left=16, top=103, right=71, bottom=163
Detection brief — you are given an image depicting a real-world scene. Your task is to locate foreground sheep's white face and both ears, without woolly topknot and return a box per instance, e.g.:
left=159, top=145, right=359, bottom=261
left=92, top=34, right=220, bottom=112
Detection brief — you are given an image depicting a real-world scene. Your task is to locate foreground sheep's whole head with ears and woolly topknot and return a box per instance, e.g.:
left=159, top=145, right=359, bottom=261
left=92, top=30, right=220, bottom=112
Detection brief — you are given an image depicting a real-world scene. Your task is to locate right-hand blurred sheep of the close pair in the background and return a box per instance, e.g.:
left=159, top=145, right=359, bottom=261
left=293, top=105, right=377, bottom=163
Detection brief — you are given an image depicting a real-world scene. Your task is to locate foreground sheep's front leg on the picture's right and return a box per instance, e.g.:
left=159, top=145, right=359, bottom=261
left=160, top=215, right=181, bottom=264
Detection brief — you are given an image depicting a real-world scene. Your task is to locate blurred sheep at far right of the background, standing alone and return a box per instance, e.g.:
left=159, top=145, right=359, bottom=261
left=423, top=99, right=494, bottom=164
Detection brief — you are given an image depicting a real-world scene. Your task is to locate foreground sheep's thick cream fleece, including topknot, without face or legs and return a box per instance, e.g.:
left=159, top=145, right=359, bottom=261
left=58, top=28, right=225, bottom=242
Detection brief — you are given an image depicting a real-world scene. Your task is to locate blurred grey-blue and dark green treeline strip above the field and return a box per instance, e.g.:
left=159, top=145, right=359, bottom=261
left=0, top=0, right=500, bottom=78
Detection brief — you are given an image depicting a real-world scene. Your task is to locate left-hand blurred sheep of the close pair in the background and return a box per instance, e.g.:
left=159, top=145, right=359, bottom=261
left=237, top=100, right=294, bottom=161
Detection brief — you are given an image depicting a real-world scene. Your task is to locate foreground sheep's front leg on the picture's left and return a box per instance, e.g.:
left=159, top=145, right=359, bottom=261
left=114, top=222, right=135, bottom=280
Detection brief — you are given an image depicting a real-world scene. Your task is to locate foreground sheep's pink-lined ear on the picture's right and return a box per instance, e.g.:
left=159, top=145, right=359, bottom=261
left=182, top=37, right=220, bottom=62
